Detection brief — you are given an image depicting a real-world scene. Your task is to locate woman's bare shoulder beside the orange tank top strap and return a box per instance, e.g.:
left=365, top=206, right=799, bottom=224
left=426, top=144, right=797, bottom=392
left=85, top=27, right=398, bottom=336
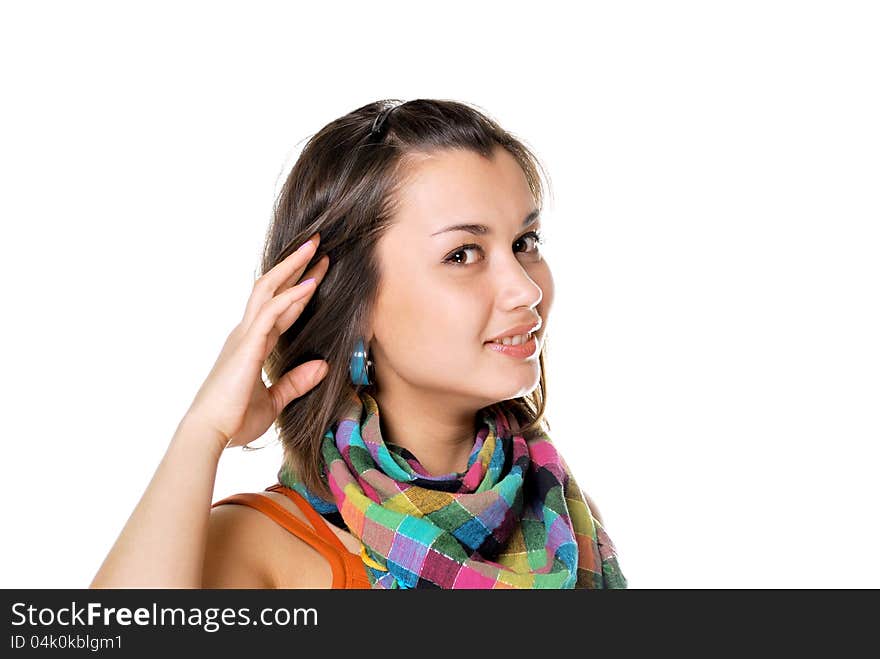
left=202, top=491, right=333, bottom=588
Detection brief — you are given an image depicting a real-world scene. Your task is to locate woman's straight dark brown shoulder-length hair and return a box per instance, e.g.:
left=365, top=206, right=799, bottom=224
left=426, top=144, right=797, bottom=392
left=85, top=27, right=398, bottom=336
left=261, top=99, right=549, bottom=500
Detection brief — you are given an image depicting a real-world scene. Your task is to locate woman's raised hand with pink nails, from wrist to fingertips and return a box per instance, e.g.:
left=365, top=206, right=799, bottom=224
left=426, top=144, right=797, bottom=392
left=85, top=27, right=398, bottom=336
left=187, top=233, right=330, bottom=448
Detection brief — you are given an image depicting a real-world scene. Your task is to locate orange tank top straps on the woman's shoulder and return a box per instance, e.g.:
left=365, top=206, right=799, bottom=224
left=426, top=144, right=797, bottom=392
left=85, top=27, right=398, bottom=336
left=211, top=483, right=371, bottom=588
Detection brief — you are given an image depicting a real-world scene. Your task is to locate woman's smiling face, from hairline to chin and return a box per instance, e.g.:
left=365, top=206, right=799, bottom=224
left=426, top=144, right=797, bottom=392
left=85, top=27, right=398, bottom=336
left=369, top=147, right=553, bottom=408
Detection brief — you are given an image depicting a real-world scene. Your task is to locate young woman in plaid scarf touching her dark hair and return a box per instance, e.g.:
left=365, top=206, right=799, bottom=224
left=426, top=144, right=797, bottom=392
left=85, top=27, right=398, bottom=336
left=91, top=99, right=626, bottom=588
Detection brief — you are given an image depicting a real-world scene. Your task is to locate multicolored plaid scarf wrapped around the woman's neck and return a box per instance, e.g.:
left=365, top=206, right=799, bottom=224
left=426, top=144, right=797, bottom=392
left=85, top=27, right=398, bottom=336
left=278, top=390, right=626, bottom=588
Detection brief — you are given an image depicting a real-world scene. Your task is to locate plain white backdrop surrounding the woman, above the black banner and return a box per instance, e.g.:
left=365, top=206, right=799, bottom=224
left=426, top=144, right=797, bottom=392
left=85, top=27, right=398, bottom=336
left=0, top=0, right=880, bottom=588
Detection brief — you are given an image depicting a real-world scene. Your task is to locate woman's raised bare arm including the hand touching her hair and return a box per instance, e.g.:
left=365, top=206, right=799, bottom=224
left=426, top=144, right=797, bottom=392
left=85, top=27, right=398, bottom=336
left=91, top=234, right=330, bottom=588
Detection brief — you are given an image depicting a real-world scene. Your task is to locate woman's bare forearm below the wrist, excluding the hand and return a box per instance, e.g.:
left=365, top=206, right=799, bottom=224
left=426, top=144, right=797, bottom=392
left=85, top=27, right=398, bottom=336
left=90, top=415, right=226, bottom=588
